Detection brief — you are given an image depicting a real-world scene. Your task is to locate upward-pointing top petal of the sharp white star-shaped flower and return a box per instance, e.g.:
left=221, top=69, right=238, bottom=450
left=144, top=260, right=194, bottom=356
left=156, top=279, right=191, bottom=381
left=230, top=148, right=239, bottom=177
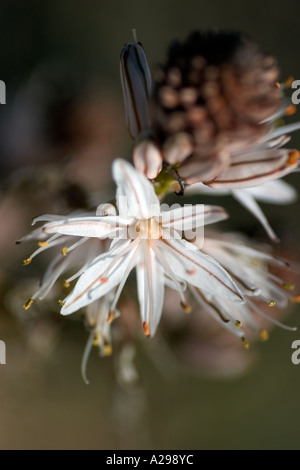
left=112, top=159, right=160, bottom=219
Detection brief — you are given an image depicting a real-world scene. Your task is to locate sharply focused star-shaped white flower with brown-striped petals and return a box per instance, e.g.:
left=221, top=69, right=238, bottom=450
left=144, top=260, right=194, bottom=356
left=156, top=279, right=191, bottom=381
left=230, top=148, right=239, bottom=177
left=22, top=159, right=244, bottom=336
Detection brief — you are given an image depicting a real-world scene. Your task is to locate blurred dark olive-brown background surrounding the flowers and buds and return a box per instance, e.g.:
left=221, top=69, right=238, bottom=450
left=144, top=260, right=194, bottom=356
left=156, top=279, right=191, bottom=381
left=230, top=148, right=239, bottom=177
left=0, top=0, right=300, bottom=449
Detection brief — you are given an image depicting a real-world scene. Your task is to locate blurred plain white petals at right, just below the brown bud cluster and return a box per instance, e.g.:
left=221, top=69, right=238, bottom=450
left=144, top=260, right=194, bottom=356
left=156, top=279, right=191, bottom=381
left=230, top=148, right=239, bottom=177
left=185, top=179, right=297, bottom=241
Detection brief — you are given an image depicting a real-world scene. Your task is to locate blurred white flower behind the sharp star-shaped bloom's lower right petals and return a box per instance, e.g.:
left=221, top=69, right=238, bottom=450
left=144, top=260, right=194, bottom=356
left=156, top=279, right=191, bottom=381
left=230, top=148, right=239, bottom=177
left=191, top=234, right=297, bottom=348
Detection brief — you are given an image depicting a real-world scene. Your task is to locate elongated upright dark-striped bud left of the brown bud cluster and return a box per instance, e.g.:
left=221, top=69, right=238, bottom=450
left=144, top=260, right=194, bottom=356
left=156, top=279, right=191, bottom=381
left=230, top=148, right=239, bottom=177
left=120, top=42, right=152, bottom=140
